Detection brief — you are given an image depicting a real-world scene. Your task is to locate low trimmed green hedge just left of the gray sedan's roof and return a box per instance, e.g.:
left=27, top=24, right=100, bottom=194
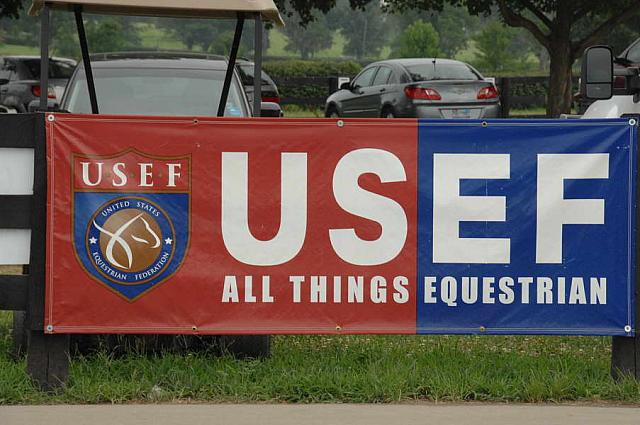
left=264, top=60, right=362, bottom=78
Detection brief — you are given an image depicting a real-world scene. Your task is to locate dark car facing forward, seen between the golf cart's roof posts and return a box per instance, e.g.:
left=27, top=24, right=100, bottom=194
left=60, top=52, right=251, bottom=117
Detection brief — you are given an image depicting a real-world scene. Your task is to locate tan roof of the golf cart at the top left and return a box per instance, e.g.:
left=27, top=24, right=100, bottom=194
left=29, top=0, right=284, bottom=25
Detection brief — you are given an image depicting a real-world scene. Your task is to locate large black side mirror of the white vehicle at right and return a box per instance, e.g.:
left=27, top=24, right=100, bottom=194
left=580, top=46, right=613, bottom=100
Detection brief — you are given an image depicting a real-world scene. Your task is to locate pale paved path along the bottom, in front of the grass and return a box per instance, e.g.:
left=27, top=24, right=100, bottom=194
left=0, top=403, right=640, bottom=425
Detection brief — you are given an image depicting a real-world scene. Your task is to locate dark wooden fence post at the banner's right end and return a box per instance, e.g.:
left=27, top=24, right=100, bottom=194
left=611, top=120, right=640, bottom=380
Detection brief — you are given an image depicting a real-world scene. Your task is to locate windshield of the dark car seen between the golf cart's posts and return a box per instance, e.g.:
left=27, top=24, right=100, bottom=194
left=63, top=68, right=247, bottom=117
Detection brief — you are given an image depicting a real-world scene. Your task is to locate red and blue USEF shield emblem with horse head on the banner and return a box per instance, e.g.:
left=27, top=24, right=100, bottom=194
left=71, top=149, right=191, bottom=302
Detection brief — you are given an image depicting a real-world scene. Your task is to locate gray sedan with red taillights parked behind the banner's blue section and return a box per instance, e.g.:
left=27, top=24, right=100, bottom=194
left=325, top=59, right=500, bottom=119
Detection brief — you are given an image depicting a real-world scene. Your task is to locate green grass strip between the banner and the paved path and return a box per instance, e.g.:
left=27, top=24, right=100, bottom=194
left=0, top=313, right=640, bottom=404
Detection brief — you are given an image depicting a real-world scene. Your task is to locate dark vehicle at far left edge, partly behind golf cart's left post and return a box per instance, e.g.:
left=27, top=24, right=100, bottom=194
left=0, top=56, right=76, bottom=112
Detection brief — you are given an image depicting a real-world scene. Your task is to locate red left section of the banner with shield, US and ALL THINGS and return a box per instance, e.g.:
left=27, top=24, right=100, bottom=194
left=45, top=114, right=417, bottom=334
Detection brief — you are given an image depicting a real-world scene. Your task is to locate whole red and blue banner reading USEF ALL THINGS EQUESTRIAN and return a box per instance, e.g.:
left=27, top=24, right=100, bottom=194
left=45, top=114, right=637, bottom=336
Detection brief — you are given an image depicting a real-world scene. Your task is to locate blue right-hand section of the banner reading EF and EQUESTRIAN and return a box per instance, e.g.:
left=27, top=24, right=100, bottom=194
left=417, top=119, right=638, bottom=336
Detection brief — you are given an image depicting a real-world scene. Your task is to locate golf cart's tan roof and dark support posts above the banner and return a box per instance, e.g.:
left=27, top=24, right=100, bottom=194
left=29, top=0, right=284, bottom=117
